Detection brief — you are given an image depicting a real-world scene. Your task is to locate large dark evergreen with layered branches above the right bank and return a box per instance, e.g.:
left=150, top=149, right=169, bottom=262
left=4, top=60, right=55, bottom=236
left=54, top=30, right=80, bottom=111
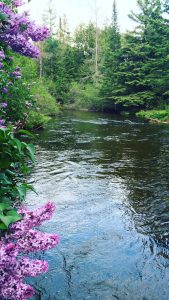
left=115, top=0, right=169, bottom=108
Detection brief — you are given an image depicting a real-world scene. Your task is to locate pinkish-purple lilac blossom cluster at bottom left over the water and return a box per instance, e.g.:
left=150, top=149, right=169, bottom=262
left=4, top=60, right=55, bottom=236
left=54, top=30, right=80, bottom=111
left=0, top=203, right=59, bottom=300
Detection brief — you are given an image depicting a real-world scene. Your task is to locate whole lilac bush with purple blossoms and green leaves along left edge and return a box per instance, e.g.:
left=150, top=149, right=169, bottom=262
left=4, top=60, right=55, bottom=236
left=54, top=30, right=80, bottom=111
left=0, top=0, right=59, bottom=300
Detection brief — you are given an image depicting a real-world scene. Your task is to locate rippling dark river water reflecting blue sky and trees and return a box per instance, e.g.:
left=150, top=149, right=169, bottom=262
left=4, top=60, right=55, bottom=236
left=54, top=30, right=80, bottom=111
left=27, top=112, right=169, bottom=300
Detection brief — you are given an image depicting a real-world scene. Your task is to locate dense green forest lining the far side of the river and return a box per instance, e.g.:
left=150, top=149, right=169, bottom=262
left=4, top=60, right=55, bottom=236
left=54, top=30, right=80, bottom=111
left=9, top=0, right=169, bottom=124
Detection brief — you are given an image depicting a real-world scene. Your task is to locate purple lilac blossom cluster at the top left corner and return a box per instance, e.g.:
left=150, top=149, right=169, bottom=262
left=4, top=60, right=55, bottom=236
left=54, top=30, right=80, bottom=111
left=0, top=0, right=50, bottom=58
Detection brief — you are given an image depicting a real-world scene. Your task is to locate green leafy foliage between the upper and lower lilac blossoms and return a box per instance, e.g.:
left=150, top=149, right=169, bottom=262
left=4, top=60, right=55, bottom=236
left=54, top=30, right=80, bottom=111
left=0, top=127, right=34, bottom=230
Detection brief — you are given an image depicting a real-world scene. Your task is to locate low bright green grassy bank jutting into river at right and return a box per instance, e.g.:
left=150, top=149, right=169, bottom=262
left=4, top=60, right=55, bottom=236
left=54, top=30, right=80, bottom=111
left=136, top=109, right=169, bottom=124
